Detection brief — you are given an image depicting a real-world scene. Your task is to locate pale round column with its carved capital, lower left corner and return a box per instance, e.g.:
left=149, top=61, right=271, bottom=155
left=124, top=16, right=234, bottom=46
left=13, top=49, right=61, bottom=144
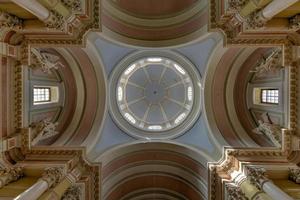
left=14, top=167, right=63, bottom=200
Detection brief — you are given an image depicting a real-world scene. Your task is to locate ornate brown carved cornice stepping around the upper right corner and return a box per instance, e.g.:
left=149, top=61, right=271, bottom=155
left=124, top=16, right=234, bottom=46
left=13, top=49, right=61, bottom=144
left=209, top=0, right=294, bottom=46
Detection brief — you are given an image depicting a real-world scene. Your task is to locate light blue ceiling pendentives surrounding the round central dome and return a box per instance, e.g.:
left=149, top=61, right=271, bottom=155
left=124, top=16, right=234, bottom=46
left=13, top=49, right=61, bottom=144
left=89, top=32, right=223, bottom=160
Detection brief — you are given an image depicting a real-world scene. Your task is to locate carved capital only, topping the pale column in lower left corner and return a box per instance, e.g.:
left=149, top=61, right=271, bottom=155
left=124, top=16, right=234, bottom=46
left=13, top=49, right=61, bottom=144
left=41, top=167, right=64, bottom=188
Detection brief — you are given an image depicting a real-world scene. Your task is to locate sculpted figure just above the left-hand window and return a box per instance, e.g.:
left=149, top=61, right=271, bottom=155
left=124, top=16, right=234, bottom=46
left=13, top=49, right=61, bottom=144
left=30, top=48, right=64, bottom=74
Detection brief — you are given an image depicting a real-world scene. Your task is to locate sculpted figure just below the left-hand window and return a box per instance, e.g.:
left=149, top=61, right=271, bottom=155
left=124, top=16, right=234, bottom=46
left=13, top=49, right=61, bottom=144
left=30, top=120, right=58, bottom=145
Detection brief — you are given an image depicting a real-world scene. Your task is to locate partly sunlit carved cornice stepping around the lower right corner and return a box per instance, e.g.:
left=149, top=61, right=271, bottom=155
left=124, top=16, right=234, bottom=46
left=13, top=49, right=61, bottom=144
left=208, top=130, right=293, bottom=199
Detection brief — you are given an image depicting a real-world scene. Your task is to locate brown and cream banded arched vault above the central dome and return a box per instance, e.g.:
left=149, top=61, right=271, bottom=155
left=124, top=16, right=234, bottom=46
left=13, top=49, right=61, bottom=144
left=102, top=0, right=208, bottom=46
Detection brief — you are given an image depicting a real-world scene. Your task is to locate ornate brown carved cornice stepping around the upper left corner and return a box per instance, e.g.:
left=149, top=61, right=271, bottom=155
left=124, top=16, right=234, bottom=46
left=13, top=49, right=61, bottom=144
left=13, top=0, right=101, bottom=65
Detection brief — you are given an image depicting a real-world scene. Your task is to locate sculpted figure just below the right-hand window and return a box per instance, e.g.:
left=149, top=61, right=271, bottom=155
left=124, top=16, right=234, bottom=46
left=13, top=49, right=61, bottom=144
left=253, top=120, right=282, bottom=147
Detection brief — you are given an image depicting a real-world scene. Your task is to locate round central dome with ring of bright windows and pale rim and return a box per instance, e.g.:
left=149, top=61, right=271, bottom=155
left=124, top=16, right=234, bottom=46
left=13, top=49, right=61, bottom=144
left=109, top=51, right=201, bottom=139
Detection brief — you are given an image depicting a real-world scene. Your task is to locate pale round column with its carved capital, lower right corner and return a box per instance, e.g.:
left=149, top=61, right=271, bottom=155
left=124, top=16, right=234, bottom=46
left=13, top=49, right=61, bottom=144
left=246, top=166, right=293, bottom=200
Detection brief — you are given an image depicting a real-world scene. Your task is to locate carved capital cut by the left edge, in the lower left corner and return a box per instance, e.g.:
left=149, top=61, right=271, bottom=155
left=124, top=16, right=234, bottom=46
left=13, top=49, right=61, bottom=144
left=0, top=167, right=23, bottom=188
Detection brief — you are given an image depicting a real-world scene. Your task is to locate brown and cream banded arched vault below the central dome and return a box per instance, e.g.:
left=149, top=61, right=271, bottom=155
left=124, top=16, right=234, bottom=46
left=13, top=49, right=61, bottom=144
left=98, top=142, right=207, bottom=200
